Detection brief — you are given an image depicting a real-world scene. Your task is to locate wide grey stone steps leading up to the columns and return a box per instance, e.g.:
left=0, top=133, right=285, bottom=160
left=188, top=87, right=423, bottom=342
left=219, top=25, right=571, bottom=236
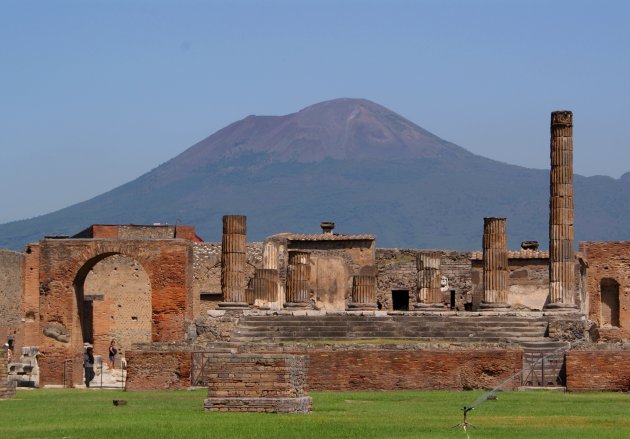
left=231, top=314, right=547, bottom=347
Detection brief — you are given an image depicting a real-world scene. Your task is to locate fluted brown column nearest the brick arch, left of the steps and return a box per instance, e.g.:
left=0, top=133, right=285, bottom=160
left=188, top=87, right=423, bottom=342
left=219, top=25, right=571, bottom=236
left=219, top=215, right=247, bottom=308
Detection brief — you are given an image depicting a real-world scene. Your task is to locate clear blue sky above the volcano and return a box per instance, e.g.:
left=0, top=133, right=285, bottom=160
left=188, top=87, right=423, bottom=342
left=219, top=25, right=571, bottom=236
left=0, top=0, right=630, bottom=223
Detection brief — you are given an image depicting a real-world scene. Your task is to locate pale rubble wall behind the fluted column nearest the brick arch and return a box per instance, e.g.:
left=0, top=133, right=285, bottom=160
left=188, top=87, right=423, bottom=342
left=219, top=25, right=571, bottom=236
left=192, top=242, right=262, bottom=317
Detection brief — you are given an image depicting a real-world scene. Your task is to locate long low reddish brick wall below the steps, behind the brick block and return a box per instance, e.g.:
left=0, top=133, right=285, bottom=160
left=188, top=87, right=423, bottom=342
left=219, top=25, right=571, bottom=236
left=127, top=346, right=522, bottom=390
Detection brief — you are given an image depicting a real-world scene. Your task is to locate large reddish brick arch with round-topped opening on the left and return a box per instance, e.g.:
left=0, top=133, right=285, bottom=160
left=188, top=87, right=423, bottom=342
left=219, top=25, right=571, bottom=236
left=40, top=239, right=192, bottom=384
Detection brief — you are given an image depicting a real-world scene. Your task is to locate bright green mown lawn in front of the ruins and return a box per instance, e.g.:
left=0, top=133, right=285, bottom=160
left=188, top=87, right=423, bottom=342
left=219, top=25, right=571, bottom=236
left=0, top=389, right=630, bottom=439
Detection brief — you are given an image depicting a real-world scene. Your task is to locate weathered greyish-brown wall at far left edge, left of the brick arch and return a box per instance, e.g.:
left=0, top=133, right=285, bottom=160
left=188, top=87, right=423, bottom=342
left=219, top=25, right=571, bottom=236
left=0, top=249, right=25, bottom=344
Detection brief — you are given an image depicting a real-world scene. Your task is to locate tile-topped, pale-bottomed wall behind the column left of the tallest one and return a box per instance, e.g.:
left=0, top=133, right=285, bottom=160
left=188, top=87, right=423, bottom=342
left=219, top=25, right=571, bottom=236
left=471, top=258, right=549, bottom=310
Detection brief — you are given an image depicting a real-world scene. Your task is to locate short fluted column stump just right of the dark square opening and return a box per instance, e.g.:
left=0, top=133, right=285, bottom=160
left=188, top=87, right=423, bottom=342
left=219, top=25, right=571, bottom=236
left=414, top=252, right=444, bottom=310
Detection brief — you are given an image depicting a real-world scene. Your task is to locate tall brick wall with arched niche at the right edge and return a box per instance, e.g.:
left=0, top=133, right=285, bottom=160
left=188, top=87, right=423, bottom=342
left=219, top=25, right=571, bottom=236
left=580, top=241, right=630, bottom=341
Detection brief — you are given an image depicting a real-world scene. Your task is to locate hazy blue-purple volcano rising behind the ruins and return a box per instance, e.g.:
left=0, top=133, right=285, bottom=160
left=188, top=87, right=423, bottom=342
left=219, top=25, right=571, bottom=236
left=0, top=99, right=630, bottom=250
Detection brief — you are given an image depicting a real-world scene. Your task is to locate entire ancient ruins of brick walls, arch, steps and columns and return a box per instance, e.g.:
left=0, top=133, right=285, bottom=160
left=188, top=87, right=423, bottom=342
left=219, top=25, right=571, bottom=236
left=0, top=111, right=630, bottom=396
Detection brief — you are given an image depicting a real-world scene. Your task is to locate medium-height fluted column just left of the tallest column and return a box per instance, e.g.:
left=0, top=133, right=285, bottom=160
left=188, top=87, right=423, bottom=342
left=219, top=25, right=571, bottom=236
left=480, top=218, right=510, bottom=310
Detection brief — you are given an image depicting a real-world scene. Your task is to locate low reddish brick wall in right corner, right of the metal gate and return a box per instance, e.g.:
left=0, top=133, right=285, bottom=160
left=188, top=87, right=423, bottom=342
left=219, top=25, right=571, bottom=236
left=566, top=350, right=630, bottom=392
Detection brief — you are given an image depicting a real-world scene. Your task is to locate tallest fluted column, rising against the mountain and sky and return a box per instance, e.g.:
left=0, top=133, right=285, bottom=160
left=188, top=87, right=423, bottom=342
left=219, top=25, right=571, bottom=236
left=545, top=111, right=576, bottom=309
